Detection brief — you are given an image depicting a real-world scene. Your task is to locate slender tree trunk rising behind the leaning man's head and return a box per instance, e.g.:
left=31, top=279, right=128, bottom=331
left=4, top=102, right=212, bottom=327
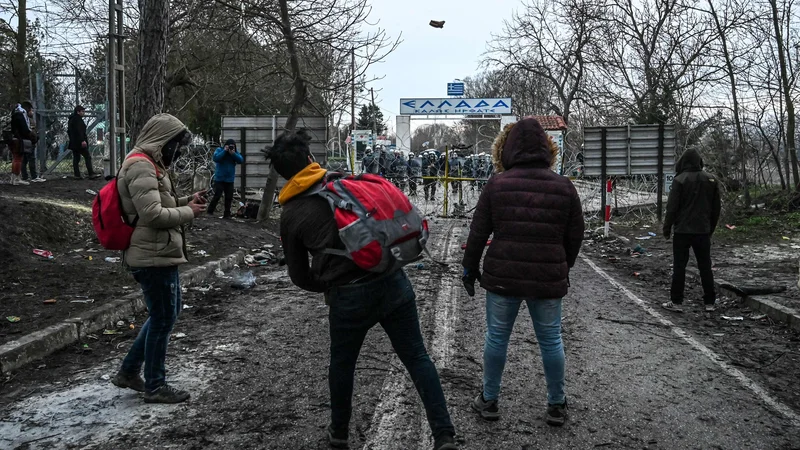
left=257, top=0, right=308, bottom=222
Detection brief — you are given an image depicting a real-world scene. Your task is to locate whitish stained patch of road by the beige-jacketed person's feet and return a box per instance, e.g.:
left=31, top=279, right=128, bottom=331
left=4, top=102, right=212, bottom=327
left=0, top=358, right=215, bottom=449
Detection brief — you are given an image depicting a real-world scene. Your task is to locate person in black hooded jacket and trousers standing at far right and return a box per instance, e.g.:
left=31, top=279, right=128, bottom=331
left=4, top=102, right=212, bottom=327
left=662, top=149, right=722, bottom=312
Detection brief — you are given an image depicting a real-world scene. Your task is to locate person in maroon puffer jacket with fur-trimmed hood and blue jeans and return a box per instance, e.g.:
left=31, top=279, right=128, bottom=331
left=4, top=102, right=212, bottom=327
left=462, top=117, right=584, bottom=426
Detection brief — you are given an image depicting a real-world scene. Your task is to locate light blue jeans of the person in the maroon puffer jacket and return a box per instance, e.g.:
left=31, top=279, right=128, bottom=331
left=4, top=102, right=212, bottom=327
left=483, top=291, right=566, bottom=405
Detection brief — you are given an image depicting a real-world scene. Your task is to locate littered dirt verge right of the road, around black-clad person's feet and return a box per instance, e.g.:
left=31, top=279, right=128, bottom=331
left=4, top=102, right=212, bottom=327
left=583, top=215, right=800, bottom=409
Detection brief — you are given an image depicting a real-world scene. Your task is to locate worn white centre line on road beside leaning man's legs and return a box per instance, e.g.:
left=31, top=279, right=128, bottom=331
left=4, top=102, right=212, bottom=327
left=364, top=222, right=458, bottom=450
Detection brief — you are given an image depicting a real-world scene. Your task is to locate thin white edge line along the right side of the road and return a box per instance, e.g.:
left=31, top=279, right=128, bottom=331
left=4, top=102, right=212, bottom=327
left=581, top=255, right=800, bottom=426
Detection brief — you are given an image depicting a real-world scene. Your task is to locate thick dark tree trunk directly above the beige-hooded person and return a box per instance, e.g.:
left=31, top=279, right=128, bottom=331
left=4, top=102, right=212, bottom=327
left=128, top=0, right=169, bottom=143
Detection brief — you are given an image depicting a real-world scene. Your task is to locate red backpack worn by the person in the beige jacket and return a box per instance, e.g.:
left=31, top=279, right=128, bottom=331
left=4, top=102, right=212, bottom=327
left=92, top=153, right=158, bottom=250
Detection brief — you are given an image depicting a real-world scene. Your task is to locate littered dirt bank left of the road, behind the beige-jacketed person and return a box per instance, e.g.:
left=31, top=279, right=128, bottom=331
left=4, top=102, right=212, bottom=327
left=0, top=178, right=275, bottom=344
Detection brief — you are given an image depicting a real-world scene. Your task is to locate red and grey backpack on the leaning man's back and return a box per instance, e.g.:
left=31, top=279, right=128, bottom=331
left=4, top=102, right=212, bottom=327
left=312, top=174, right=428, bottom=273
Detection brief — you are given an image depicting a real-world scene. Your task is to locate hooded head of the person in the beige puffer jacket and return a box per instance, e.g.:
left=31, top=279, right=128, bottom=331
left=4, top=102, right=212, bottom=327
left=134, top=114, right=192, bottom=167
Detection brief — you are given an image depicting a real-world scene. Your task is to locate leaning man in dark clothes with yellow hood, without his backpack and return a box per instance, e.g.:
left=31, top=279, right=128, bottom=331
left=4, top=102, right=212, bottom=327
left=267, top=130, right=458, bottom=450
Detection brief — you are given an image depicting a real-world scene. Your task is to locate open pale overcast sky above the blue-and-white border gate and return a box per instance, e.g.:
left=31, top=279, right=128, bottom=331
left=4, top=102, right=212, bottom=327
left=369, top=0, right=521, bottom=130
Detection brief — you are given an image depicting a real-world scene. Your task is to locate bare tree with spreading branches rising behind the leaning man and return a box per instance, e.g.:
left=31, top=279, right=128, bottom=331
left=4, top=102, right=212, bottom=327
left=211, top=0, right=400, bottom=220
